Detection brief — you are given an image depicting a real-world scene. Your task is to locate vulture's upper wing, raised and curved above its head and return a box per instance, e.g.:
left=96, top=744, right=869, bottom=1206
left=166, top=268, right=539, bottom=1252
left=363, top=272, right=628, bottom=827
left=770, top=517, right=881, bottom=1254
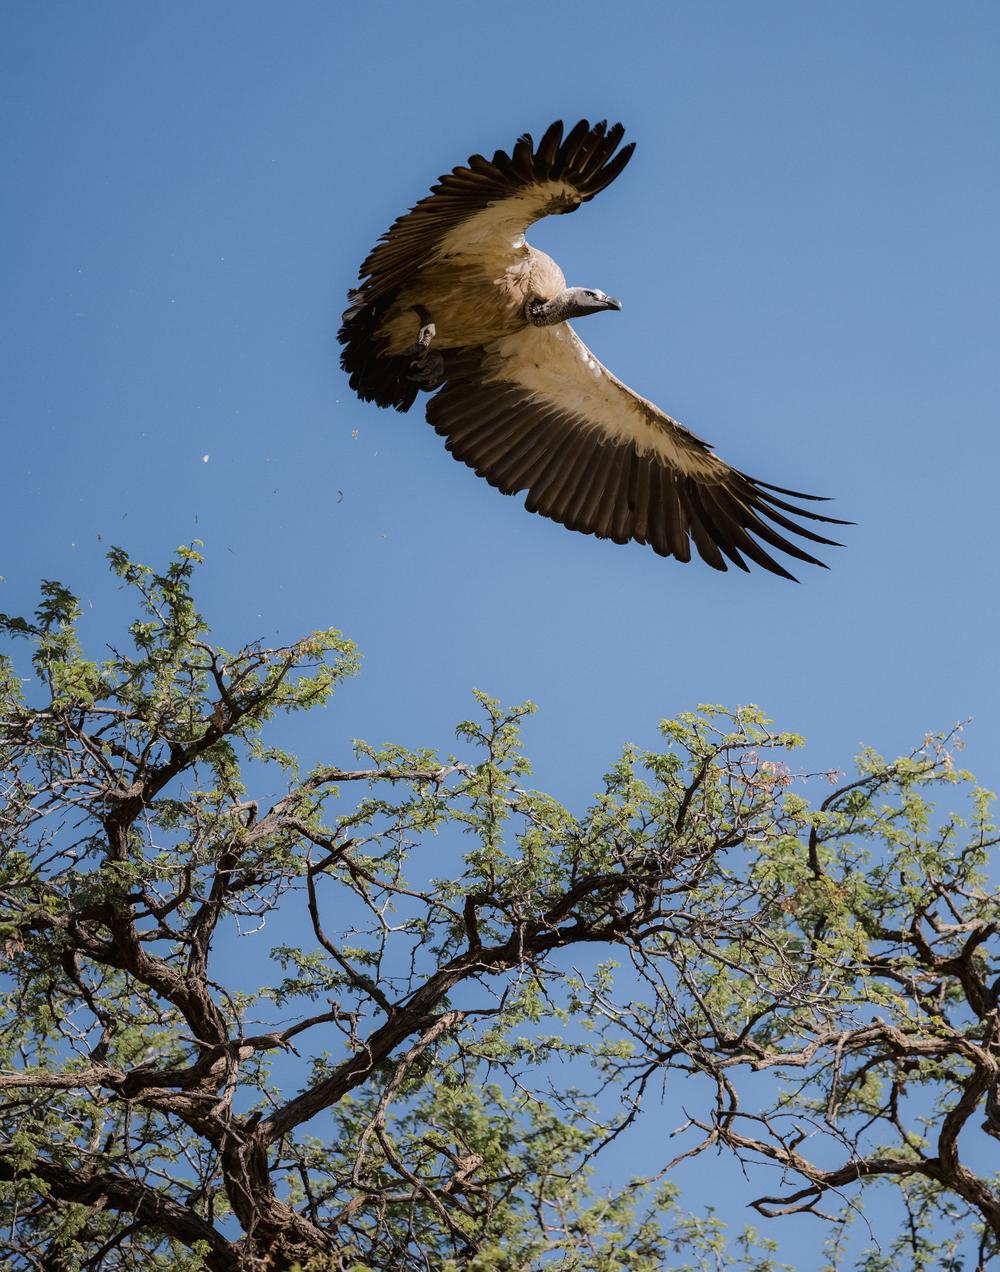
left=345, top=120, right=635, bottom=305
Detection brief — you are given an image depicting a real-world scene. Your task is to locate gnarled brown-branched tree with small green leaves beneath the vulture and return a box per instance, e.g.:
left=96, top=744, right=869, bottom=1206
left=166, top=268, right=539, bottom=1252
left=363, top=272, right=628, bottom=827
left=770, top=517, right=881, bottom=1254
left=0, top=550, right=1000, bottom=1272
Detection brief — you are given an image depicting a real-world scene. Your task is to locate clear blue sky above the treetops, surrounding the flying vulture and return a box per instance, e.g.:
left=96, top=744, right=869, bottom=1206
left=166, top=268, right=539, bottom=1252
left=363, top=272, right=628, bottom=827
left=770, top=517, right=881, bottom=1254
left=0, top=0, right=1000, bottom=1261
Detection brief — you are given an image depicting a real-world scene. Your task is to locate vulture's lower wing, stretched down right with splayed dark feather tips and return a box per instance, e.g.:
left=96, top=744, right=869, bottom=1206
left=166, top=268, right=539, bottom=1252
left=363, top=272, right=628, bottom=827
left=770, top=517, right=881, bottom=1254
left=427, top=323, right=846, bottom=579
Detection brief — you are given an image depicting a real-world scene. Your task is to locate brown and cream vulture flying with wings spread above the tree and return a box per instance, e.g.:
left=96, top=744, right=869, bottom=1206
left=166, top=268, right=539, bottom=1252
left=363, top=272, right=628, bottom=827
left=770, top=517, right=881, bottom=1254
left=340, top=120, right=849, bottom=579
